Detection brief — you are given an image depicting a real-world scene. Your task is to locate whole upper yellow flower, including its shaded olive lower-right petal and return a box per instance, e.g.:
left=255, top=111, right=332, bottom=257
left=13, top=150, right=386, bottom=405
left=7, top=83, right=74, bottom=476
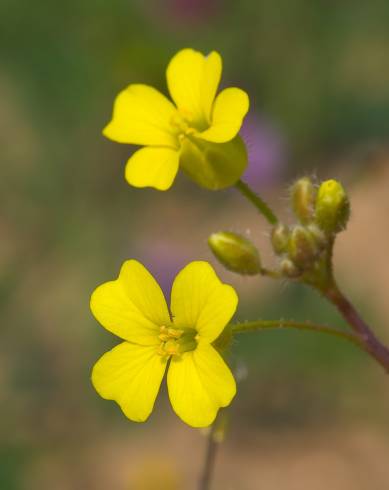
left=103, top=49, right=249, bottom=190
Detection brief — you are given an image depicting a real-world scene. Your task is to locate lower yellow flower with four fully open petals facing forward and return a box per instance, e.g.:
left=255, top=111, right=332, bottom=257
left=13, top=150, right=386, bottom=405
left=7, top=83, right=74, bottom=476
left=91, top=260, right=238, bottom=427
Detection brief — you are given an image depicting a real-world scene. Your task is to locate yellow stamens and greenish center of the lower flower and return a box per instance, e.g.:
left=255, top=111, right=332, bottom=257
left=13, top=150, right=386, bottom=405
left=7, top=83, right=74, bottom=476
left=158, top=325, right=197, bottom=357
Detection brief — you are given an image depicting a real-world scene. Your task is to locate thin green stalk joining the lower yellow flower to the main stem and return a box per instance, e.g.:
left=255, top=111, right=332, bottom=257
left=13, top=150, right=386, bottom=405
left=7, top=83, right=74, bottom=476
left=231, top=320, right=366, bottom=351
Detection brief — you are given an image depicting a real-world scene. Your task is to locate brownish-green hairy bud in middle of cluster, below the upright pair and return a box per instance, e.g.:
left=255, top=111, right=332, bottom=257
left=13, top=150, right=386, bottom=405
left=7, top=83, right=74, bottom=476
left=288, top=225, right=319, bottom=269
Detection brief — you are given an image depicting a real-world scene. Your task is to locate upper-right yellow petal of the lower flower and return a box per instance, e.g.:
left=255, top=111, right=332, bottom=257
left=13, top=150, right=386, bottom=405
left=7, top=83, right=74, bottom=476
left=171, top=262, right=238, bottom=342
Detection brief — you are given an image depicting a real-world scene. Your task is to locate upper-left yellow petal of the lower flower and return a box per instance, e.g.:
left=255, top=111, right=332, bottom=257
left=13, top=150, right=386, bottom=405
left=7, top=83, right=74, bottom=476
left=90, top=260, right=170, bottom=345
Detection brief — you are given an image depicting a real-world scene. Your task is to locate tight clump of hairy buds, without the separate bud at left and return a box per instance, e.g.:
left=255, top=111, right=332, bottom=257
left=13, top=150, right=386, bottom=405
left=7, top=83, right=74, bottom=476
left=272, top=177, right=350, bottom=278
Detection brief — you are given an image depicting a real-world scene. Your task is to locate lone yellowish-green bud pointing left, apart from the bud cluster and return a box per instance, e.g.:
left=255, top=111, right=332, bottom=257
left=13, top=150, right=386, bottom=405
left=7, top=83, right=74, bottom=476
left=208, top=231, right=261, bottom=276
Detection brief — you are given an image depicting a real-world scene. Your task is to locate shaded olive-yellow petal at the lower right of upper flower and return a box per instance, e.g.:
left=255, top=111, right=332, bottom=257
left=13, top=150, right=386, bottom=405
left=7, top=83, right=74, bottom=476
left=180, top=136, right=247, bottom=190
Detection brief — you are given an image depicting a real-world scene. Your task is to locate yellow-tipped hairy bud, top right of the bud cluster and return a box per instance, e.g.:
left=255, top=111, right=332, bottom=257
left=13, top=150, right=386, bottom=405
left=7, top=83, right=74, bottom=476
left=315, top=180, right=350, bottom=234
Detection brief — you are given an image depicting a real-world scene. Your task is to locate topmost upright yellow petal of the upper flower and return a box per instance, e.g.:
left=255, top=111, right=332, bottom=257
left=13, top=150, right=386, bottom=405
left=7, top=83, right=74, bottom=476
left=166, top=49, right=222, bottom=128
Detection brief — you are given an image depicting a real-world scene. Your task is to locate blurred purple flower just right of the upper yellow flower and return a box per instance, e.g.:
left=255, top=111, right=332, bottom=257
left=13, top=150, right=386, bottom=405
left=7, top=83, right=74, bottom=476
left=240, top=113, right=286, bottom=188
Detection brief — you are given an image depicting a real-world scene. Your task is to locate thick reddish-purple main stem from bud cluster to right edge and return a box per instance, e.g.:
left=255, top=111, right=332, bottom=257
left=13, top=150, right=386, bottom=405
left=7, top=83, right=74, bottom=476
left=323, top=283, right=389, bottom=373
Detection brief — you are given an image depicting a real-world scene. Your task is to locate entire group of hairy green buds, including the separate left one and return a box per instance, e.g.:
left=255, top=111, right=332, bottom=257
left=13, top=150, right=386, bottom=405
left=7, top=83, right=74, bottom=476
left=208, top=177, right=350, bottom=280
